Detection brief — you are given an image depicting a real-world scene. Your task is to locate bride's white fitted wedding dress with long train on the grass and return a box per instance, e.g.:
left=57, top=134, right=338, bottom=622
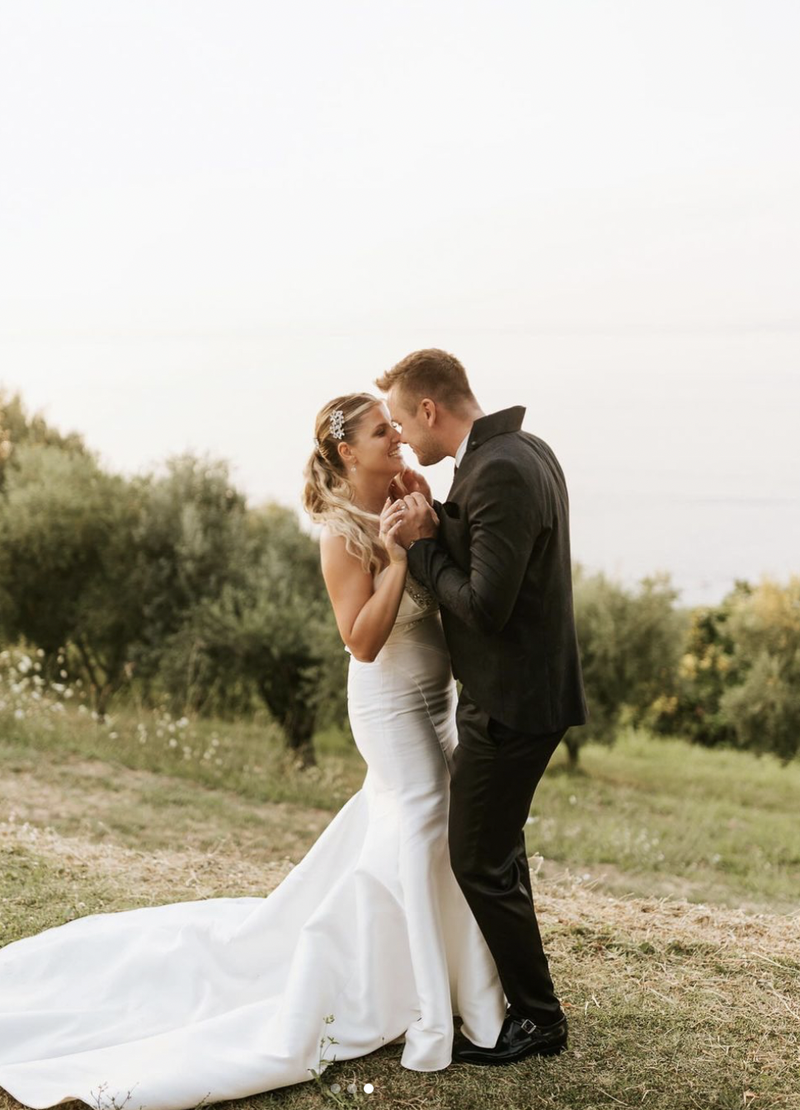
left=0, top=572, right=505, bottom=1110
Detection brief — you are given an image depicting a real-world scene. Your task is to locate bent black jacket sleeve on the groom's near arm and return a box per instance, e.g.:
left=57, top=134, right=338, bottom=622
left=408, top=458, right=543, bottom=635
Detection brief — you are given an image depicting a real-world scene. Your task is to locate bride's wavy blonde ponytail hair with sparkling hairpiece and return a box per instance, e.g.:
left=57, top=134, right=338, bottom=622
left=303, top=393, right=385, bottom=574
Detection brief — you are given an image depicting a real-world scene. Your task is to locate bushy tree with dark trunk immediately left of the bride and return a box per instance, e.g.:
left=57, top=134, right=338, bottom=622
left=153, top=506, right=346, bottom=764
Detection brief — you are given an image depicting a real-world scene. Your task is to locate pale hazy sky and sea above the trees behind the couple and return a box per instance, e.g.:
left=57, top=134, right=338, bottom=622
left=0, top=0, right=800, bottom=601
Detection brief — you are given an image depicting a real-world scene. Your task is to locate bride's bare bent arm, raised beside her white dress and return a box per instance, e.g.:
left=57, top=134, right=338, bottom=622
left=320, top=528, right=407, bottom=663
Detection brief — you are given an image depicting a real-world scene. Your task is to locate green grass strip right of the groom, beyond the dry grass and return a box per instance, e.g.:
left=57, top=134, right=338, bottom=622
left=527, top=733, right=800, bottom=912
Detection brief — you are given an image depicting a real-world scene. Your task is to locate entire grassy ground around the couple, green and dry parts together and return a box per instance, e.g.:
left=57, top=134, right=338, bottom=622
left=0, top=706, right=800, bottom=1110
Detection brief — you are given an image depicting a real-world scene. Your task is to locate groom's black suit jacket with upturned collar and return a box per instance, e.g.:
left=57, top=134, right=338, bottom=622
left=408, top=406, right=587, bottom=733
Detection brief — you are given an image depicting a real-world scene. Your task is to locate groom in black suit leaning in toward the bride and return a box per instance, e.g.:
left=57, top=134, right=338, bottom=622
left=376, top=349, right=586, bottom=1063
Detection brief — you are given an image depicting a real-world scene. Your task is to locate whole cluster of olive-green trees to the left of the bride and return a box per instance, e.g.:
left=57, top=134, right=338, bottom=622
left=0, top=397, right=346, bottom=764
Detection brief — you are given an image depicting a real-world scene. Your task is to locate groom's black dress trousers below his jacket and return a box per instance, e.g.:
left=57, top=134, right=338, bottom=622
left=449, top=689, right=566, bottom=1025
